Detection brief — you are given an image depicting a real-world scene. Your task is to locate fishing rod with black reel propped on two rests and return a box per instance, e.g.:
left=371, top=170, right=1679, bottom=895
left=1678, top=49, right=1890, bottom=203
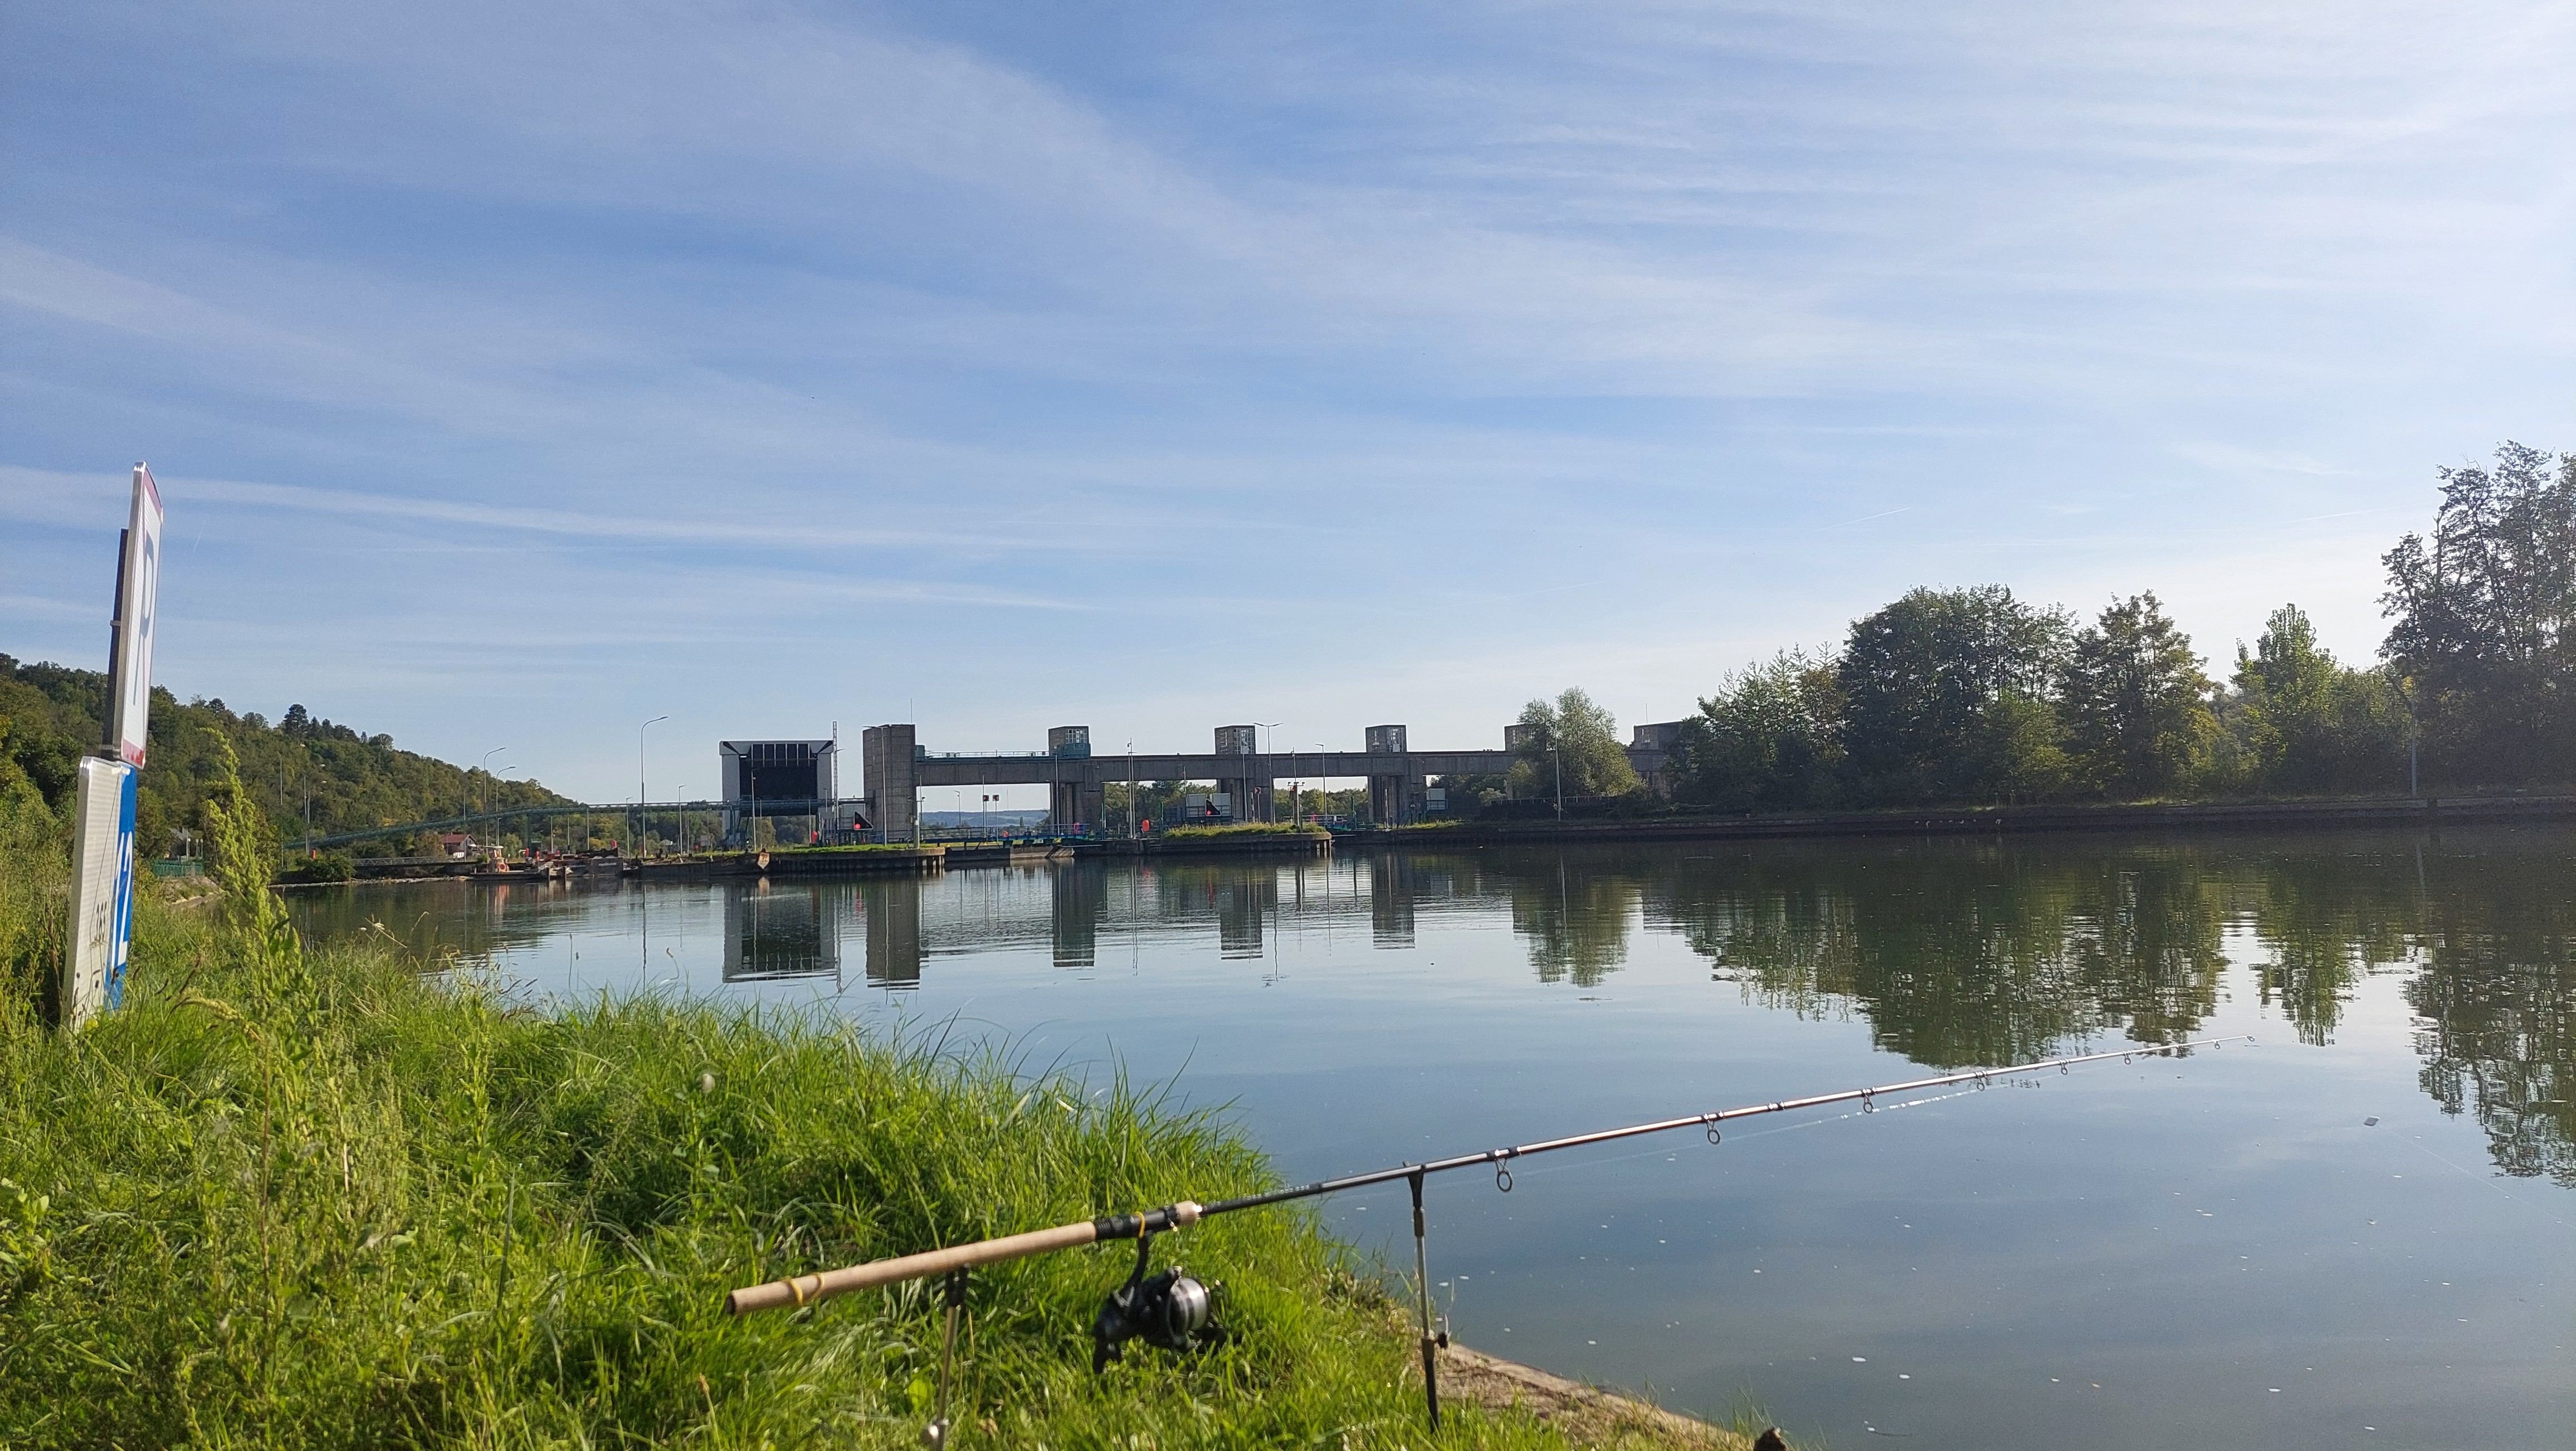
left=724, top=1034, right=2254, bottom=1446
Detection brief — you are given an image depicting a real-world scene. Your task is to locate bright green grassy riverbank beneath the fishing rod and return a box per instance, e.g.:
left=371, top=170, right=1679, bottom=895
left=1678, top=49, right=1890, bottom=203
left=0, top=793, right=1752, bottom=1448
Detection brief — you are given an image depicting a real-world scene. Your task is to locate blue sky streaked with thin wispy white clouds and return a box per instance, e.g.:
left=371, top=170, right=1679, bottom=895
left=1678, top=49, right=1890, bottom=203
left=0, top=0, right=2576, bottom=799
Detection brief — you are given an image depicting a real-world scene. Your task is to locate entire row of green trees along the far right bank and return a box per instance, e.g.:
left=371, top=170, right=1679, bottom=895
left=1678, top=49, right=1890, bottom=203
left=1453, top=444, right=2576, bottom=812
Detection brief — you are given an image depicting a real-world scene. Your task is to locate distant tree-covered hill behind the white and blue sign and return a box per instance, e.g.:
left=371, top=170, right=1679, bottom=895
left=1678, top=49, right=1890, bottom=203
left=0, top=655, right=569, bottom=856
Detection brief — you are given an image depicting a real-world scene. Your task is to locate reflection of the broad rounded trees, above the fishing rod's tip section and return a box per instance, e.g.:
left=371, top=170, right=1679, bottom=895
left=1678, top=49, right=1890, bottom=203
left=1648, top=843, right=2226, bottom=1067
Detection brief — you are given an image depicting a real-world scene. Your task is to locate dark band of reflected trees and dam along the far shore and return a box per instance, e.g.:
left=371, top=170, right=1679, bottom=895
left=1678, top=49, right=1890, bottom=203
left=291, top=830, right=2576, bottom=1186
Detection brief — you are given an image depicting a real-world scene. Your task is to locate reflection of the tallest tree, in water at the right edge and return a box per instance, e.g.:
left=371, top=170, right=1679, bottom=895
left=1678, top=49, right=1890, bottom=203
left=2406, top=856, right=2576, bottom=1188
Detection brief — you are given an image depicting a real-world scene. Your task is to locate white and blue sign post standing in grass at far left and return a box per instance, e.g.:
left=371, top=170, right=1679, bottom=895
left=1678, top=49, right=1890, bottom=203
left=62, top=464, right=162, bottom=1031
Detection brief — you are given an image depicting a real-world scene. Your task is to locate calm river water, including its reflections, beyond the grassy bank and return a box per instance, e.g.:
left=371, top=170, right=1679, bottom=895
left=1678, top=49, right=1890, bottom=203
left=296, top=830, right=2576, bottom=1451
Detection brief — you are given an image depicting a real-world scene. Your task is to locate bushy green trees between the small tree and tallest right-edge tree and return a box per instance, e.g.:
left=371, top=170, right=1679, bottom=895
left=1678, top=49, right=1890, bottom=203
left=1672, top=585, right=2406, bottom=812
